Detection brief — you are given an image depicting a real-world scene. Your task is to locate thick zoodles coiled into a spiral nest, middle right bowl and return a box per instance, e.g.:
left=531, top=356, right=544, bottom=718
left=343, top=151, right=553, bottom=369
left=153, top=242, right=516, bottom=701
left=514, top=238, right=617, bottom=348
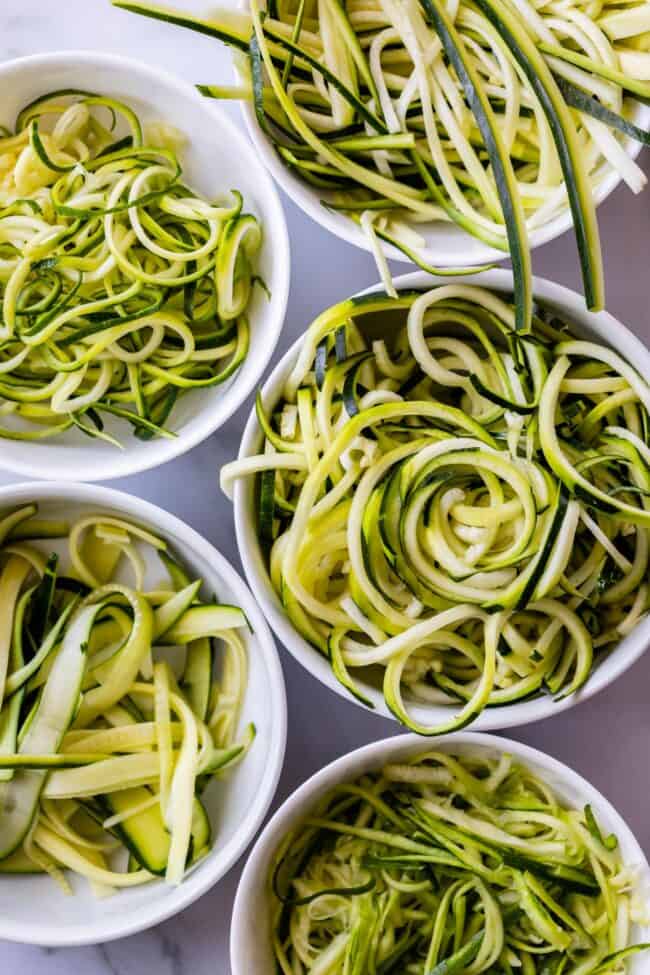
left=222, top=284, right=650, bottom=734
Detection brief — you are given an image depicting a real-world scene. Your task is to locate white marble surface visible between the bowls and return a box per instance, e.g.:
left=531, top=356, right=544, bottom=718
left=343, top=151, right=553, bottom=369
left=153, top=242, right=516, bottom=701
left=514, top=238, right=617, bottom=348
left=0, top=0, right=650, bottom=975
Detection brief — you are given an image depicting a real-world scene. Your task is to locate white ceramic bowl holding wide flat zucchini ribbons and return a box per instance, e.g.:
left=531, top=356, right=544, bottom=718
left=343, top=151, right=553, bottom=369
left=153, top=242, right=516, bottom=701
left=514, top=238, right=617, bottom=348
left=0, top=482, right=286, bottom=946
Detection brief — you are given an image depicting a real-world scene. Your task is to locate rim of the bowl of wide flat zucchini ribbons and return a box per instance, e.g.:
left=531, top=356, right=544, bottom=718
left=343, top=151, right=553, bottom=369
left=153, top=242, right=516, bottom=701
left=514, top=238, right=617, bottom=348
left=0, top=481, right=287, bottom=947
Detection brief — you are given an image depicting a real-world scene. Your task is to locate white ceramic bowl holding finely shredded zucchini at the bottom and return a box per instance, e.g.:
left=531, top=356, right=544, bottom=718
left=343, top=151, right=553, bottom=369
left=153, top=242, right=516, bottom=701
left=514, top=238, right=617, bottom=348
left=230, top=731, right=650, bottom=975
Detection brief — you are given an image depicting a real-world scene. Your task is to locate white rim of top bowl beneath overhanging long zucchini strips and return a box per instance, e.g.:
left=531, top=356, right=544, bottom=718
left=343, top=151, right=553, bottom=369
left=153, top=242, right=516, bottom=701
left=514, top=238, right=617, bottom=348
left=235, top=82, right=650, bottom=268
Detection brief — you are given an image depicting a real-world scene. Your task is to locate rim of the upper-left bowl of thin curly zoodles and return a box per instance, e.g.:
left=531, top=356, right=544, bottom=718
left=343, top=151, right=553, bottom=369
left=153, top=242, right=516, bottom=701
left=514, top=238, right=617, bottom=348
left=0, top=49, right=291, bottom=482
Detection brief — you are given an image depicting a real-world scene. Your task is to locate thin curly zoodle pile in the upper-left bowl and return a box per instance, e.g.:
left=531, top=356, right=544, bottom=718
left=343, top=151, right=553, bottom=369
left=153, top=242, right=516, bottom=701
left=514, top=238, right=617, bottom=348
left=0, top=90, right=261, bottom=443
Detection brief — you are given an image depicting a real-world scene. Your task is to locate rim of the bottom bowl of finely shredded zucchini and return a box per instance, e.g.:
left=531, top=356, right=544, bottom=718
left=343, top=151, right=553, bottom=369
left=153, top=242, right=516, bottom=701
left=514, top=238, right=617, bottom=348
left=230, top=731, right=650, bottom=975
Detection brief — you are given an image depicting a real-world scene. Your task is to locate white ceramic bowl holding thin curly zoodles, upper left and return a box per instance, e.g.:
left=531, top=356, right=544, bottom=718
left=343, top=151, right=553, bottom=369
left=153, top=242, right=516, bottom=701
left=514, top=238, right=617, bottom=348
left=0, top=51, right=290, bottom=481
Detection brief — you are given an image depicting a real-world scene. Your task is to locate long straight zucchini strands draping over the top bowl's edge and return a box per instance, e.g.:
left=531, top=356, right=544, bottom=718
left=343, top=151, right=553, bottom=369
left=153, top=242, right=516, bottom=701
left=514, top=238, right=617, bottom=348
left=113, top=0, right=650, bottom=328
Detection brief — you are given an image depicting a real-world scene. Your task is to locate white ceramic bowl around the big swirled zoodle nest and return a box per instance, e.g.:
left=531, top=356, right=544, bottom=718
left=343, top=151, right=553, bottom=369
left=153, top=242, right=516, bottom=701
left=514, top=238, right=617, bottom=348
left=234, top=270, right=650, bottom=730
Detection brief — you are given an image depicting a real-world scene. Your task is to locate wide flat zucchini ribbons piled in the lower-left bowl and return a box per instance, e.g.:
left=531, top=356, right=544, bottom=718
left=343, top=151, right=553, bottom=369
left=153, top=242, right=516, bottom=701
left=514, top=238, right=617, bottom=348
left=0, top=505, right=254, bottom=896
